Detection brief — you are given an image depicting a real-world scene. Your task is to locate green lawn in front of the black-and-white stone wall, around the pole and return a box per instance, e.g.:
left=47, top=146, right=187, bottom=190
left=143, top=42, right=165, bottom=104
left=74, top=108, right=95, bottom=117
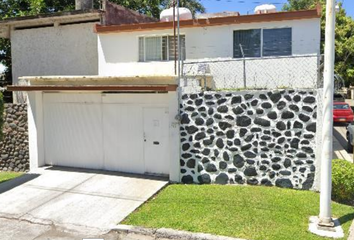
left=123, top=185, right=354, bottom=240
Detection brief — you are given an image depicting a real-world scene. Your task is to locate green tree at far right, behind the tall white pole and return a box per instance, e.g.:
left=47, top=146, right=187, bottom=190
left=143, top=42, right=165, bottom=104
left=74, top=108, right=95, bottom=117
left=283, top=0, right=354, bottom=86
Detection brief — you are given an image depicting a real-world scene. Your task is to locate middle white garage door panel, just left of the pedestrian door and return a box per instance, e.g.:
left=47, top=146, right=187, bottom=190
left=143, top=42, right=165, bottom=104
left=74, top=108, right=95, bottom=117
left=103, top=104, right=144, bottom=173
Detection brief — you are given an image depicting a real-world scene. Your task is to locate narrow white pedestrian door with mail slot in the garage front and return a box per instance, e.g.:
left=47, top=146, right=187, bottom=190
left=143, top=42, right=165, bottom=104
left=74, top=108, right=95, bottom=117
left=143, top=107, right=169, bottom=174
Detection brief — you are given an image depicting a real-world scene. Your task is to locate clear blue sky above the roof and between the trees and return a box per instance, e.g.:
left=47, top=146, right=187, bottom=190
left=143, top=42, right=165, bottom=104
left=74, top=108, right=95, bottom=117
left=200, top=0, right=354, bottom=18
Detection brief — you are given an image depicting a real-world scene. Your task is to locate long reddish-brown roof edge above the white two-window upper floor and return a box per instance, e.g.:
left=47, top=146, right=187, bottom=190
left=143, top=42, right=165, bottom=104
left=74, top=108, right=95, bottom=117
left=95, top=6, right=321, bottom=34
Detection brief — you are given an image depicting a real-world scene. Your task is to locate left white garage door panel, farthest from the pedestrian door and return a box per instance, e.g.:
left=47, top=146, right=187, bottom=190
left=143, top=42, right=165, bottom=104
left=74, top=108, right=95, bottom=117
left=44, top=103, right=103, bottom=168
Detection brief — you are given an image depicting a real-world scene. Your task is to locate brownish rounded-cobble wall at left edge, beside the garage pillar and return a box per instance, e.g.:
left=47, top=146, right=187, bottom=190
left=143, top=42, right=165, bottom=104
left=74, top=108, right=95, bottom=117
left=0, top=104, right=29, bottom=172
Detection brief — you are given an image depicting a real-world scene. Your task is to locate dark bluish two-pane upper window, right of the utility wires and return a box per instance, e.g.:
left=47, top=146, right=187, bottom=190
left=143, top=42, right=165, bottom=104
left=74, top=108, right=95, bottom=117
left=233, top=28, right=292, bottom=58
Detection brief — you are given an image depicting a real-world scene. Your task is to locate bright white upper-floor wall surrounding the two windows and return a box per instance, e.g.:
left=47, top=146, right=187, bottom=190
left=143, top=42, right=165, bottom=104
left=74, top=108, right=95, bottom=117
left=98, top=19, right=321, bottom=76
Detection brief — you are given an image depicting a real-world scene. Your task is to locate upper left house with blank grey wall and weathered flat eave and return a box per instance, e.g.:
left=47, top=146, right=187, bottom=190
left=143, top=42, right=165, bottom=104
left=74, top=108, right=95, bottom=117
left=0, top=10, right=101, bottom=102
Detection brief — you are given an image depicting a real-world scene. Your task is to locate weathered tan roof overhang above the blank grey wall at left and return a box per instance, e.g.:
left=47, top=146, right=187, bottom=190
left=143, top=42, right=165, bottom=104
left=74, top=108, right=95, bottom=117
left=0, top=9, right=103, bottom=38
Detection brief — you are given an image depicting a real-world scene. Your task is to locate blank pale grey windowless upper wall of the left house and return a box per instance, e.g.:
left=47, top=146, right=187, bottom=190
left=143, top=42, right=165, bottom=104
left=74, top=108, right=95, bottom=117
left=11, top=23, right=98, bottom=101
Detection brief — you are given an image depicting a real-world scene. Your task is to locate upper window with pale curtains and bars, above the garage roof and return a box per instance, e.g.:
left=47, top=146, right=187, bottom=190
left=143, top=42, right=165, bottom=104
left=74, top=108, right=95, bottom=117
left=139, top=35, right=186, bottom=62
